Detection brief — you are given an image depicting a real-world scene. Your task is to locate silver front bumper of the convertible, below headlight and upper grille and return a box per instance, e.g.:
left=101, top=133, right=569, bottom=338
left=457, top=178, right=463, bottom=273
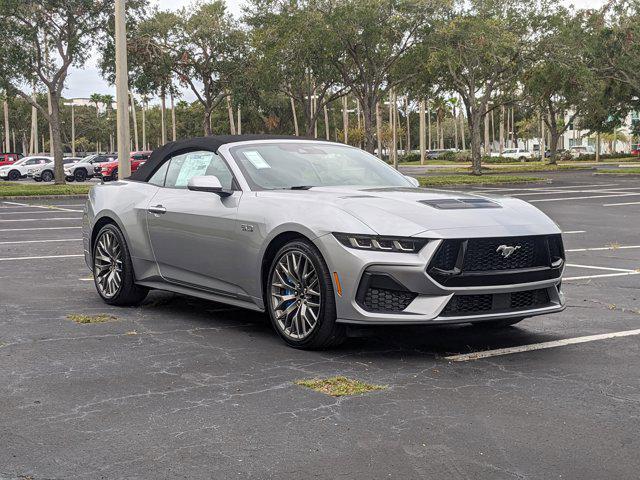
left=315, top=234, right=565, bottom=325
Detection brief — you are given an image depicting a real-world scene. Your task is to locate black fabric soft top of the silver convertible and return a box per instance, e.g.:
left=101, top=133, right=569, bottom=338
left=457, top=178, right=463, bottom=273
left=129, top=135, right=321, bottom=182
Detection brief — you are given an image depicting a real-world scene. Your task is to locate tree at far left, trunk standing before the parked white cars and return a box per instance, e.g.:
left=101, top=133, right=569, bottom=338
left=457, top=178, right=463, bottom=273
left=0, top=0, right=112, bottom=183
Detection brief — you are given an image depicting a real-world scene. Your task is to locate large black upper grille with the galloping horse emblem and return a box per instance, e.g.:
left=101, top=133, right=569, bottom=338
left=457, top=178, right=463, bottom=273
left=427, top=235, right=564, bottom=287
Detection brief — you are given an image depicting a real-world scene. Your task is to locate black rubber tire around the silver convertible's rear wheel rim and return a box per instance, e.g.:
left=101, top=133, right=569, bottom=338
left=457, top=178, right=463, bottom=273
left=91, top=223, right=149, bottom=306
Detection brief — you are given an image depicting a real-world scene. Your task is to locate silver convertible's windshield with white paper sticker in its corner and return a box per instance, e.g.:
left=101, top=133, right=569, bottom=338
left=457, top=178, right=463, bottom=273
left=231, top=142, right=412, bottom=190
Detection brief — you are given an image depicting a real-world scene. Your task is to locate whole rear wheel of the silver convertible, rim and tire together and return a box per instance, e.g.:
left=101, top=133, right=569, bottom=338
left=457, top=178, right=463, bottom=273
left=93, top=223, right=149, bottom=306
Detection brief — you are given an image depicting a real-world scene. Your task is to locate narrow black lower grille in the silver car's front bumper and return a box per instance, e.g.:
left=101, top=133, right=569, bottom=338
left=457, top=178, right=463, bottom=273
left=440, top=288, right=551, bottom=317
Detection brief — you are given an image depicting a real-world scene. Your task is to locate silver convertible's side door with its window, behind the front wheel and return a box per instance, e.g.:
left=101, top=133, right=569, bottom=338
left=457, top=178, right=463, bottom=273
left=147, top=151, right=243, bottom=297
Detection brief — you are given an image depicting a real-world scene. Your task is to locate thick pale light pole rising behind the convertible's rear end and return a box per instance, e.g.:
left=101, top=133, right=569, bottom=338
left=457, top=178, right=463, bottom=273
left=115, top=0, right=131, bottom=179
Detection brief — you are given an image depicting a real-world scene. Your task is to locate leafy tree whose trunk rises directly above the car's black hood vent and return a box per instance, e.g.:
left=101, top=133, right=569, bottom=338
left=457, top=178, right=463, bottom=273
left=428, top=0, right=534, bottom=175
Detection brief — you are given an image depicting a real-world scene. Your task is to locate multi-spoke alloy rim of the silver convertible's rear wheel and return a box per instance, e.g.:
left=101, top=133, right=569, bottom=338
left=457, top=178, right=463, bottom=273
left=93, top=231, right=123, bottom=298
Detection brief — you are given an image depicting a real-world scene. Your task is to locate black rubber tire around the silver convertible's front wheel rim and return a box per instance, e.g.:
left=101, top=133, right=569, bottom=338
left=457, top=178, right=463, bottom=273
left=264, top=240, right=346, bottom=350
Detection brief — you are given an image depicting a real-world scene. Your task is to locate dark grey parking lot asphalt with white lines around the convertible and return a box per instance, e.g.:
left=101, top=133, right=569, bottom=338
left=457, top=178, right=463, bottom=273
left=0, top=172, right=640, bottom=480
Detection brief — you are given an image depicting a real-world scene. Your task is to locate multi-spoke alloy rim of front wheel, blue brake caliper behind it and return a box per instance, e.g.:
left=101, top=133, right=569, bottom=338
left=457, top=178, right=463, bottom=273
left=271, top=250, right=322, bottom=340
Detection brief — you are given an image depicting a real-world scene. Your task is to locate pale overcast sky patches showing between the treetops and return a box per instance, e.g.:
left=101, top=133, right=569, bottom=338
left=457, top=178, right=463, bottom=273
left=63, top=0, right=604, bottom=101
